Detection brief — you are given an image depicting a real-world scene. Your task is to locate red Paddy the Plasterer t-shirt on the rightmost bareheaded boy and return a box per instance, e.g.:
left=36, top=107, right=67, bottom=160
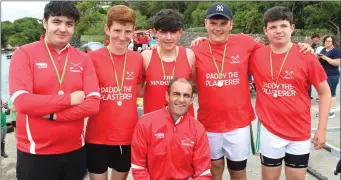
left=250, top=44, right=327, bottom=141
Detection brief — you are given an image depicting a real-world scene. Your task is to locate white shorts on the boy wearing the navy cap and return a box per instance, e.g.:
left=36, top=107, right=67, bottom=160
left=207, top=125, right=252, bottom=161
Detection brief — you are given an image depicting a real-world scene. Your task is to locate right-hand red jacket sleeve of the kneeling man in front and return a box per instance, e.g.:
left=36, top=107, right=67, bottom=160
left=193, top=125, right=212, bottom=180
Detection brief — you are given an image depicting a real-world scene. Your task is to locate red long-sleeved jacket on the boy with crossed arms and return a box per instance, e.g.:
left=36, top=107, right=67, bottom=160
left=9, top=38, right=100, bottom=154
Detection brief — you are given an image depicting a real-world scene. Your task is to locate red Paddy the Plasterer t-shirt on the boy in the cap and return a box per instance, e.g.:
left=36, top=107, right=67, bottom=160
left=193, top=34, right=262, bottom=132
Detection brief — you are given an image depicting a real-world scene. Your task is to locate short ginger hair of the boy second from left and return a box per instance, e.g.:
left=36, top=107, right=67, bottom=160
left=107, top=5, right=136, bottom=28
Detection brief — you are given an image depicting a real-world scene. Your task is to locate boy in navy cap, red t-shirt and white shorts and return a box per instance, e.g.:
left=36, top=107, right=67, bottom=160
left=192, top=3, right=263, bottom=179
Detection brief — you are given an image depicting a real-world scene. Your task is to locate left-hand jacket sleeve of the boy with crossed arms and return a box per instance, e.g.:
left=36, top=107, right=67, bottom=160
left=9, top=47, right=71, bottom=116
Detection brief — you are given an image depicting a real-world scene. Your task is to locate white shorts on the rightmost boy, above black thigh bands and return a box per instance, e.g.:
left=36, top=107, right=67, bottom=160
left=260, top=125, right=310, bottom=159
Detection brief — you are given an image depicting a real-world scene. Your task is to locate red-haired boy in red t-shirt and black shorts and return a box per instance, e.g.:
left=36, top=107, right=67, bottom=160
left=86, top=5, right=142, bottom=180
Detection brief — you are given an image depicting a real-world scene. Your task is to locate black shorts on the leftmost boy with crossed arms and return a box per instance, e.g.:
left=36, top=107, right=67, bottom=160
left=17, top=148, right=86, bottom=180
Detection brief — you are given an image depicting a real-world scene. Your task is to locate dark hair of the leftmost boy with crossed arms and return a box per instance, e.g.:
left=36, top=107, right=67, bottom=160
left=44, top=1, right=80, bottom=22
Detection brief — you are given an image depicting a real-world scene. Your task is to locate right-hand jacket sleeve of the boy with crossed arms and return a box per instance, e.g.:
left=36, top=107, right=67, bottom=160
left=56, top=56, right=101, bottom=121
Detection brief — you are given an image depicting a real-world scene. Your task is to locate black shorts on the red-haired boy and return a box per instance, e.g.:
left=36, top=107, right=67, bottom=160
left=85, top=143, right=131, bottom=174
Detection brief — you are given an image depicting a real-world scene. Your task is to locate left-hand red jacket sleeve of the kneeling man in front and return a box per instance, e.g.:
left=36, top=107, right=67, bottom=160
left=131, top=119, right=150, bottom=180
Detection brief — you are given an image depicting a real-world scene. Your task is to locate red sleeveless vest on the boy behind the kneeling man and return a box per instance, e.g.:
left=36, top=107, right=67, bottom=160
left=143, top=46, right=194, bottom=116
